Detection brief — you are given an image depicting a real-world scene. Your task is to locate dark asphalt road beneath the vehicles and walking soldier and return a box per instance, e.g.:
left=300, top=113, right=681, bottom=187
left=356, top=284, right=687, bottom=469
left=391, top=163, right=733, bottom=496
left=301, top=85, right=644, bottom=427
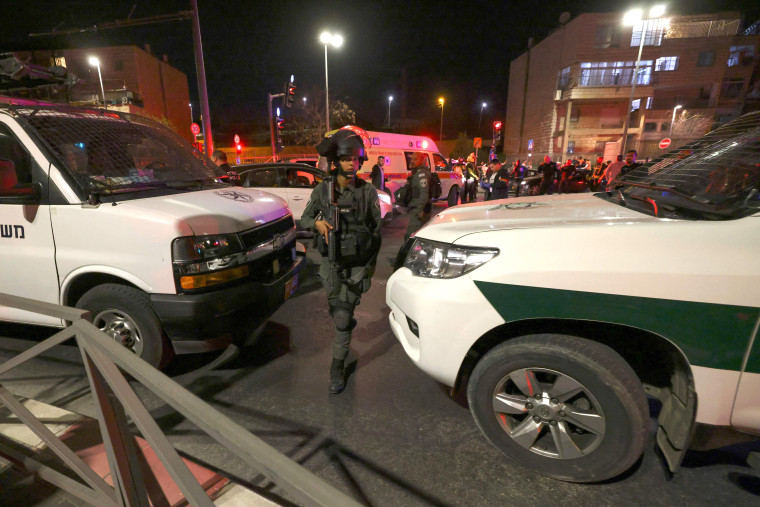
left=0, top=196, right=760, bottom=506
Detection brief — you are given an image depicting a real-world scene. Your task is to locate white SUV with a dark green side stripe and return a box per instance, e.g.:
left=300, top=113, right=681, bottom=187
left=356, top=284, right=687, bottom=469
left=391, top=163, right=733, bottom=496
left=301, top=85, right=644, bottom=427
left=386, top=113, right=760, bottom=482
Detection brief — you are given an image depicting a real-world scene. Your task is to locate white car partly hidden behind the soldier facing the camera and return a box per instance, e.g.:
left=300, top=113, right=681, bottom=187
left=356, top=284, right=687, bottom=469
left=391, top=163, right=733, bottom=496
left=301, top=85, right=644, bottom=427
left=235, top=162, right=393, bottom=226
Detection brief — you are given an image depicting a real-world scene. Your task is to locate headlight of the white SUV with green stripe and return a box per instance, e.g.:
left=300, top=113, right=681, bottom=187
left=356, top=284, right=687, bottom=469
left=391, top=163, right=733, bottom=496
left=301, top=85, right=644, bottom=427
left=404, top=238, right=499, bottom=278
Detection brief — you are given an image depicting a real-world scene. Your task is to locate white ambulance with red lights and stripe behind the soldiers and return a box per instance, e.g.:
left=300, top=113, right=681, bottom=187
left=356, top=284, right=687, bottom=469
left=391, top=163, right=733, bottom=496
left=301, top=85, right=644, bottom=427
left=318, top=125, right=464, bottom=206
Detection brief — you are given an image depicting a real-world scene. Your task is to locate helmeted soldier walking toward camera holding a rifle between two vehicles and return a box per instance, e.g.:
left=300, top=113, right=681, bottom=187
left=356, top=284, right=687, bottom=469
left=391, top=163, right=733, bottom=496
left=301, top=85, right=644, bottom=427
left=301, top=130, right=381, bottom=394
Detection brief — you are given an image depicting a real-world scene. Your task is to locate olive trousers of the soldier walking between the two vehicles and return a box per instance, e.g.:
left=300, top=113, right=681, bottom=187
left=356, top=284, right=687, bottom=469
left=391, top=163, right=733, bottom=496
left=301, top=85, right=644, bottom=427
left=319, top=258, right=365, bottom=360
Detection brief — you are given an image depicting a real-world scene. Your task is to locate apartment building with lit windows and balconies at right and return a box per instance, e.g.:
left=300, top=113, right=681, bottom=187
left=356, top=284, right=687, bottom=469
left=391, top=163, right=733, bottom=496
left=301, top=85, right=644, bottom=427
left=504, top=12, right=760, bottom=160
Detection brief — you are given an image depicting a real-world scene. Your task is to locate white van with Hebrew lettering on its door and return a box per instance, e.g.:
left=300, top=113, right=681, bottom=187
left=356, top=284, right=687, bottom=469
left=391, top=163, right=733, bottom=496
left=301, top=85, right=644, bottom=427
left=0, top=99, right=304, bottom=365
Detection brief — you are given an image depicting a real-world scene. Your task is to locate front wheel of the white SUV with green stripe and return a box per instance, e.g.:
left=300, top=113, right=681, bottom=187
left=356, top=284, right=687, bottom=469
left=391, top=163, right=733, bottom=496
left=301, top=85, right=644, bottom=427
left=467, top=335, right=649, bottom=482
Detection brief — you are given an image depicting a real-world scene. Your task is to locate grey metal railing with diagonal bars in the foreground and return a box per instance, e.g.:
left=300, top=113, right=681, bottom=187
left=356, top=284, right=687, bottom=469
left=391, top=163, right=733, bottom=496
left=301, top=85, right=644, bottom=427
left=0, top=293, right=359, bottom=507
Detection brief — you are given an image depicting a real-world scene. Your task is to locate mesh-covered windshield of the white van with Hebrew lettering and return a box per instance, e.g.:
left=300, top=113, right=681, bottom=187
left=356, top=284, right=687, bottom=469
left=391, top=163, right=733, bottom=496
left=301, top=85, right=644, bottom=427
left=16, top=107, right=223, bottom=198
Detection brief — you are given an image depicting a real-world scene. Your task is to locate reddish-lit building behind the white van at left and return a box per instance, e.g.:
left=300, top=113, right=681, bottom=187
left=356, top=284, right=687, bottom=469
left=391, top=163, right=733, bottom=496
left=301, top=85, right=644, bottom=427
left=0, top=46, right=193, bottom=141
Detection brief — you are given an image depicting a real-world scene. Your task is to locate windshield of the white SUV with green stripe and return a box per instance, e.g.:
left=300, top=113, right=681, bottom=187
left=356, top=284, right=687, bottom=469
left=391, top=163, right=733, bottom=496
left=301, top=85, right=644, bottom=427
left=599, top=112, right=760, bottom=220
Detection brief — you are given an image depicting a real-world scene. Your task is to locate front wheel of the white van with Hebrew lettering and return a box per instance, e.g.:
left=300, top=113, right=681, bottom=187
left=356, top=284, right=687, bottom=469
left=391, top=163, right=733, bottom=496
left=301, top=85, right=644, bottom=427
left=76, top=283, right=170, bottom=368
